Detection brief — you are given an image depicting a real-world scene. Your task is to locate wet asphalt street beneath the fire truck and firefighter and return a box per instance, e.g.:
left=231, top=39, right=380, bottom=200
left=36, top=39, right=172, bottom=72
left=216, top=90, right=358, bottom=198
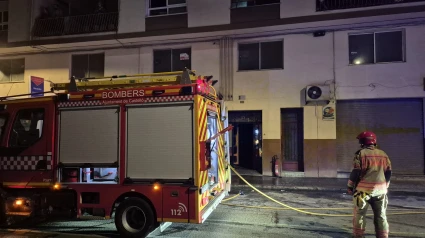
left=0, top=189, right=425, bottom=238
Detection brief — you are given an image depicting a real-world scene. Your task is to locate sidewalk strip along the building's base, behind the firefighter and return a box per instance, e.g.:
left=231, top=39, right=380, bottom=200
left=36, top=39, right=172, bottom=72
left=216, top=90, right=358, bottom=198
left=231, top=172, right=425, bottom=193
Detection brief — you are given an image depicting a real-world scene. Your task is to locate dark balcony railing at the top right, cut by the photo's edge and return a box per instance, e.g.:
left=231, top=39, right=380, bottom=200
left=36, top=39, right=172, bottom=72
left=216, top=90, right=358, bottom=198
left=316, top=0, right=425, bottom=12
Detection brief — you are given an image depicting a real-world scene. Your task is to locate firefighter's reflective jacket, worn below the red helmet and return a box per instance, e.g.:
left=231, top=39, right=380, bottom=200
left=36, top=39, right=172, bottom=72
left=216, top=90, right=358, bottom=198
left=347, top=146, right=392, bottom=196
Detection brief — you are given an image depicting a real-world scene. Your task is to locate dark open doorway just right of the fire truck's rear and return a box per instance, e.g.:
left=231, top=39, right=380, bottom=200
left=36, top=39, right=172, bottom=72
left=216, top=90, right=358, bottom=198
left=229, top=111, right=263, bottom=174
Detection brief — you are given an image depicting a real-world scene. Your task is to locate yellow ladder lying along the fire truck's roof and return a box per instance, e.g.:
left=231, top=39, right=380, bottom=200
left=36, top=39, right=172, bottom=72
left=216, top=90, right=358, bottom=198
left=50, top=69, right=205, bottom=92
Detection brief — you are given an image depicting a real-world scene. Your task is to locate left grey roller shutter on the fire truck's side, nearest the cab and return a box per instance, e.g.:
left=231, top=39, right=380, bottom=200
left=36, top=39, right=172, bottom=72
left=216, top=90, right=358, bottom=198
left=59, top=107, right=120, bottom=164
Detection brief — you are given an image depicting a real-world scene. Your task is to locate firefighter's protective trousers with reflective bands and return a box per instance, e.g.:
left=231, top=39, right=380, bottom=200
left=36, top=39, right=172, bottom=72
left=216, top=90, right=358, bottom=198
left=353, top=192, right=389, bottom=238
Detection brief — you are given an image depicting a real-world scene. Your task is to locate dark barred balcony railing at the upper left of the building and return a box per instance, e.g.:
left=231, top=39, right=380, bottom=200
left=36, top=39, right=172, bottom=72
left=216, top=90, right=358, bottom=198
left=33, top=12, right=118, bottom=37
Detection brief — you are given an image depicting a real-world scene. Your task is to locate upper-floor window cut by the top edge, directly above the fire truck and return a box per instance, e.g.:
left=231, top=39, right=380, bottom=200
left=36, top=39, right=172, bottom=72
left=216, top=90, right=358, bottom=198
left=147, top=0, right=187, bottom=16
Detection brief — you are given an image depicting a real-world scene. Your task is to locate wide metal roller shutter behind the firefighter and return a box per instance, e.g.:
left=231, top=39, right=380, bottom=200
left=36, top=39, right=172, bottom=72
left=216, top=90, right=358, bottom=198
left=336, top=99, right=424, bottom=175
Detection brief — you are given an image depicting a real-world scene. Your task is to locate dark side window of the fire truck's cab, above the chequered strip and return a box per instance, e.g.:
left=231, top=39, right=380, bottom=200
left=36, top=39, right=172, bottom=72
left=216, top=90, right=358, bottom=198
left=9, top=108, right=44, bottom=147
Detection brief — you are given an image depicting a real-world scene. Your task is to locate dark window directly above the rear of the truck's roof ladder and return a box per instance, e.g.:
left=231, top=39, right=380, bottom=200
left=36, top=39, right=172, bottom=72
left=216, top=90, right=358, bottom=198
left=153, top=48, right=191, bottom=73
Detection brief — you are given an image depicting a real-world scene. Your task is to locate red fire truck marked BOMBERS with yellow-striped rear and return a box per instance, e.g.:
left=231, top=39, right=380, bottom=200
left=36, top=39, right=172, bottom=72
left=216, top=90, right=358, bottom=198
left=0, top=69, right=232, bottom=237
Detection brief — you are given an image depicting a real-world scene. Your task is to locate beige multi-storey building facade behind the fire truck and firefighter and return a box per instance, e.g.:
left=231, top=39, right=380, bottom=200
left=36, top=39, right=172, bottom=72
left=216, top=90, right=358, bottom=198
left=0, top=0, right=425, bottom=177
